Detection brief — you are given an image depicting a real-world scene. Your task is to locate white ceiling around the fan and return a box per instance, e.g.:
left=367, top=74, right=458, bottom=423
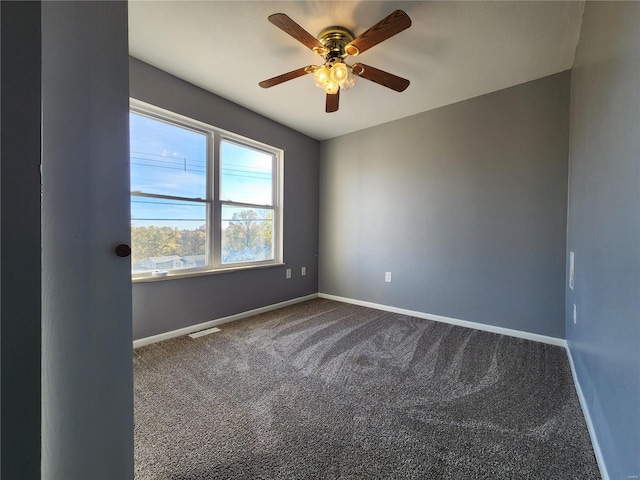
left=129, top=1, right=584, bottom=140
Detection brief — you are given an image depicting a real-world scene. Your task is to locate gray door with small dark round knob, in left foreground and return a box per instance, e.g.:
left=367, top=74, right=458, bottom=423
left=41, top=2, right=133, bottom=480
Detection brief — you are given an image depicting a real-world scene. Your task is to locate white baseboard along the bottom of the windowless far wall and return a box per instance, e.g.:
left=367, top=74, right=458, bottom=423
left=318, top=293, right=567, bottom=348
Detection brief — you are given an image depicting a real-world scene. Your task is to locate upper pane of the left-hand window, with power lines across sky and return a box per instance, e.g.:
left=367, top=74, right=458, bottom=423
left=129, top=112, right=207, bottom=199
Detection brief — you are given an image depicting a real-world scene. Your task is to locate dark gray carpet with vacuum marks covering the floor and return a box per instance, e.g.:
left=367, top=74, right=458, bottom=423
left=134, top=299, right=600, bottom=480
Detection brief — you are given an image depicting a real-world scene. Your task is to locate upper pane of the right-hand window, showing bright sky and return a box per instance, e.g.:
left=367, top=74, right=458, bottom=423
left=220, top=141, right=273, bottom=205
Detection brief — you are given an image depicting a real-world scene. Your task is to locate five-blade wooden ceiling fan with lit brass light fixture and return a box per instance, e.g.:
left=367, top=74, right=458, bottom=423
left=258, top=10, right=411, bottom=113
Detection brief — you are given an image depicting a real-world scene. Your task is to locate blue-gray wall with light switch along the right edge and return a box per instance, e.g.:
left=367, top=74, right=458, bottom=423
left=566, top=2, right=640, bottom=479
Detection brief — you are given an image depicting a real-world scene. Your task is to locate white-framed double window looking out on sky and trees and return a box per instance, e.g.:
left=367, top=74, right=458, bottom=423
left=129, top=100, right=282, bottom=277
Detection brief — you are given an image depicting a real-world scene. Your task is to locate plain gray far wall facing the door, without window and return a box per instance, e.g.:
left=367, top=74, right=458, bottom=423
left=319, top=72, right=570, bottom=338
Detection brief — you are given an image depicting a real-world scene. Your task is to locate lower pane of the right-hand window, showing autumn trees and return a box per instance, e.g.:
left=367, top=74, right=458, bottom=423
left=222, top=205, right=273, bottom=263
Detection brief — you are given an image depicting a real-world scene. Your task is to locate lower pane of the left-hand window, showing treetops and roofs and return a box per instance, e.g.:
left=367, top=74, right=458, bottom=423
left=131, top=196, right=207, bottom=272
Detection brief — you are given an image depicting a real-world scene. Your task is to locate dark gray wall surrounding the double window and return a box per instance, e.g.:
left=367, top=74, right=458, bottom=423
left=130, top=59, right=319, bottom=339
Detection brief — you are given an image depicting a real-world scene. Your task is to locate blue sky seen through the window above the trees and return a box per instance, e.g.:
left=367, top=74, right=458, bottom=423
left=129, top=113, right=272, bottom=229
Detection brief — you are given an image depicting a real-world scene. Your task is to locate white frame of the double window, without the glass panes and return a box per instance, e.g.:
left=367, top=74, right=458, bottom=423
left=129, top=98, right=284, bottom=281
